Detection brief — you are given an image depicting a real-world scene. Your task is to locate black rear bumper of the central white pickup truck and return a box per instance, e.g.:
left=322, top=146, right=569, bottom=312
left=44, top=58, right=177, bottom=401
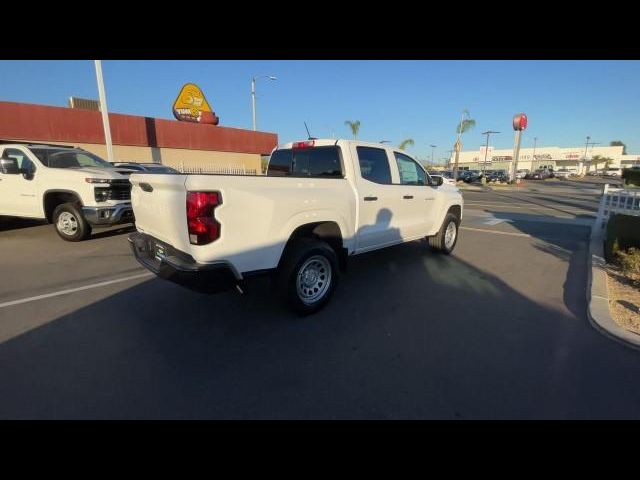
left=129, top=232, right=246, bottom=293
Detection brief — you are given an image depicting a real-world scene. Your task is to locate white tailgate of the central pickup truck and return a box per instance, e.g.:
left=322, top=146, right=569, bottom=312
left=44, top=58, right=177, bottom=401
left=130, top=173, right=189, bottom=255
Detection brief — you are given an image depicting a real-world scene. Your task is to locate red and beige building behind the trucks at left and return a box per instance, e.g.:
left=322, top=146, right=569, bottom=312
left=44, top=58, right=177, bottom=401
left=0, top=102, right=278, bottom=173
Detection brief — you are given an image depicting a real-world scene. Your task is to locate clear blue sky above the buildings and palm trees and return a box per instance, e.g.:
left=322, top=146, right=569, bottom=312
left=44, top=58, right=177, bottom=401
left=0, top=60, right=640, bottom=161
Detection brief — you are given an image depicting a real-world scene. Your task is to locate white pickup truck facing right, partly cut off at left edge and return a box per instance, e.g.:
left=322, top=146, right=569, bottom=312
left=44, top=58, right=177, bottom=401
left=0, top=143, right=133, bottom=242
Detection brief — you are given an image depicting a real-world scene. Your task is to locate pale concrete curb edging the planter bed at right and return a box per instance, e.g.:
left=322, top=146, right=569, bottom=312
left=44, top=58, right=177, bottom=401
left=587, top=231, right=640, bottom=350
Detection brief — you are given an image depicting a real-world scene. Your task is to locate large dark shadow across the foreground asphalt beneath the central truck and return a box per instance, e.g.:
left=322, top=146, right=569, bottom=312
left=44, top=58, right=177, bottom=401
left=0, top=236, right=640, bottom=419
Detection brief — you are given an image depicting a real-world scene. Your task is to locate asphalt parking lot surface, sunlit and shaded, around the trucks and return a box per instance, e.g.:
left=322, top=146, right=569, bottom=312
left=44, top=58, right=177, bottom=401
left=0, top=181, right=640, bottom=419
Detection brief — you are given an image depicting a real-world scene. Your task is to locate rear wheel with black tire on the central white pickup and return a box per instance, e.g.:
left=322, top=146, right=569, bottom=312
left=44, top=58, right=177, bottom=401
left=276, top=238, right=340, bottom=315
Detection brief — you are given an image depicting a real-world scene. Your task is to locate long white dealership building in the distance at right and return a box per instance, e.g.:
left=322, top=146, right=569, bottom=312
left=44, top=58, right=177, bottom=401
left=449, top=145, right=640, bottom=173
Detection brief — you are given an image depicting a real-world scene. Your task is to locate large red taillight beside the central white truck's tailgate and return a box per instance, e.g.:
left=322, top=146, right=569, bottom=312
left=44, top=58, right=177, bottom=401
left=187, top=192, right=222, bottom=245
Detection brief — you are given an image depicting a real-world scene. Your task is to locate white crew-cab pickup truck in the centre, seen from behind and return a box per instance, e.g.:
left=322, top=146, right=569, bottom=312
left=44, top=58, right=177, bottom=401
left=129, top=139, right=463, bottom=314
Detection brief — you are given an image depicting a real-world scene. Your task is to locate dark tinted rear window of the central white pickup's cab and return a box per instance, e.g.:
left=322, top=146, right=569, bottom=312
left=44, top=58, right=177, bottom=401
left=267, top=146, right=343, bottom=178
